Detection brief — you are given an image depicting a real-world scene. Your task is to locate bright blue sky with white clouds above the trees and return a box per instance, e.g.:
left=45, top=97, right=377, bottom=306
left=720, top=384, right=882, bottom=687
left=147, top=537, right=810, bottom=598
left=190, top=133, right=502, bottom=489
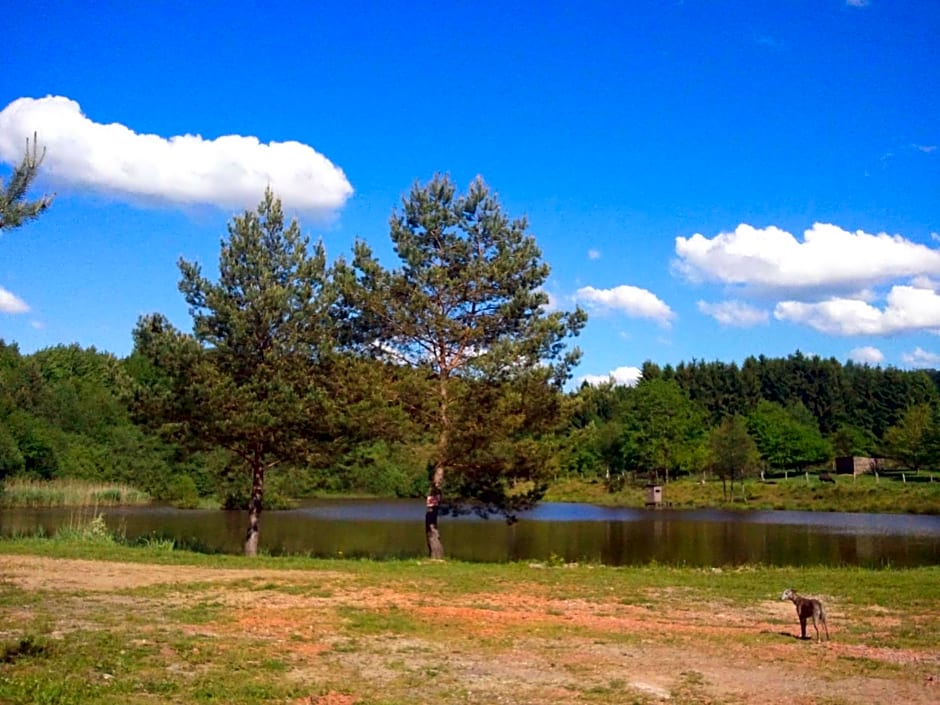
left=0, top=0, right=940, bottom=382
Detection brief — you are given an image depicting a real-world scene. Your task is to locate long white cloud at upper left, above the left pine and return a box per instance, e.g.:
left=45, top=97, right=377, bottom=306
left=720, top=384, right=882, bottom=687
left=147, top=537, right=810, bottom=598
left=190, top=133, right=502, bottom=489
left=0, top=96, right=353, bottom=216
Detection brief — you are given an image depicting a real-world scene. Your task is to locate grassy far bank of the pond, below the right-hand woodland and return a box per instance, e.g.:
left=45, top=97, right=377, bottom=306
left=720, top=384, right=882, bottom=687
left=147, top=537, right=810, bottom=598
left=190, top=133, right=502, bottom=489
left=545, top=474, right=940, bottom=514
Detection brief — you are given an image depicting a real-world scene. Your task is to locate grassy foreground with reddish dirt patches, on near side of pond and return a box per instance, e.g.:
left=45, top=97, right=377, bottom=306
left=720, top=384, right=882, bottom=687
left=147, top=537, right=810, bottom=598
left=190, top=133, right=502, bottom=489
left=0, top=531, right=940, bottom=705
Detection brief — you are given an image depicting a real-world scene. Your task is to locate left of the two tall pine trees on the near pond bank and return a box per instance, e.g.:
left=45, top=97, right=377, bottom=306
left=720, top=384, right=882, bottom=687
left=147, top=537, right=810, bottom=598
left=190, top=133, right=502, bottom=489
left=135, top=190, right=336, bottom=555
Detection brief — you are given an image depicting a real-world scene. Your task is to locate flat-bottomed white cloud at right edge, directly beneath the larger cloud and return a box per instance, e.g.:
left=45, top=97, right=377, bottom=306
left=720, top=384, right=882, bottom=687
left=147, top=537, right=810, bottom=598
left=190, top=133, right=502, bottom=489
left=774, top=286, right=940, bottom=336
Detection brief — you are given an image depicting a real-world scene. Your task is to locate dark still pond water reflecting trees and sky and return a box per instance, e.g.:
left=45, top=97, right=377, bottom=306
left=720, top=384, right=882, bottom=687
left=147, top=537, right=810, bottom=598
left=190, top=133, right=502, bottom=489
left=0, top=500, right=940, bottom=567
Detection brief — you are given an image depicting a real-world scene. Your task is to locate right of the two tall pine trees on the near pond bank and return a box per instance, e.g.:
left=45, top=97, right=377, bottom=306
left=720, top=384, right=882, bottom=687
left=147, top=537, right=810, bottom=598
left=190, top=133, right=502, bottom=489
left=348, top=175, right=586, bottom=558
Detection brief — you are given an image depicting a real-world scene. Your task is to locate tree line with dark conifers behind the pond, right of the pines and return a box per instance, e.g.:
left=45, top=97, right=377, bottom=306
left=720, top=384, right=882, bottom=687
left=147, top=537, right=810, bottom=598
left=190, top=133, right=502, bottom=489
left=562, top=358, right=940, bottom=500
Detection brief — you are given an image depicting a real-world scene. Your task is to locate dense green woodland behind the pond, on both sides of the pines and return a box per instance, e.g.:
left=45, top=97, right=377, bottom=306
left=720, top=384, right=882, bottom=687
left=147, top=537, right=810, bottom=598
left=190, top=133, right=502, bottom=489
left=0, top=343, right=940, bottom=498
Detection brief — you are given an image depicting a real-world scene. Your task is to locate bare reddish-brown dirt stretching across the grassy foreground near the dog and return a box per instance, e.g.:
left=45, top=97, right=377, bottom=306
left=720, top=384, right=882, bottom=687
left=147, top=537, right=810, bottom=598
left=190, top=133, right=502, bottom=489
left=0, top=556, right=940, bottom=705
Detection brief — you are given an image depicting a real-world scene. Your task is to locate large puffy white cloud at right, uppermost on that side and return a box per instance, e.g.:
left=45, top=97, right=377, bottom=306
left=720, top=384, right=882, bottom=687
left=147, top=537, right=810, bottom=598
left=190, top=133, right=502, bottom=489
left=674, top=223, right=940, bottom=294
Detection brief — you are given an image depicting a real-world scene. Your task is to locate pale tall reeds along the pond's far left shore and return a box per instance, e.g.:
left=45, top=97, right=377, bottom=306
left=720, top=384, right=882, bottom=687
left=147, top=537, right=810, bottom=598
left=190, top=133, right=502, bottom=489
left=0, top=478, right=150, bottom=507
